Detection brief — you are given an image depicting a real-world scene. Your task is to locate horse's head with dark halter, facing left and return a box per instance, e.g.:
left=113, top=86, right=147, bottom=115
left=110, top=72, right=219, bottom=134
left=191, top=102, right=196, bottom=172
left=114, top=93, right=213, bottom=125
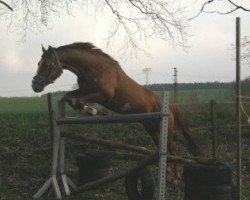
left=32, top=46, right=63, bottom=92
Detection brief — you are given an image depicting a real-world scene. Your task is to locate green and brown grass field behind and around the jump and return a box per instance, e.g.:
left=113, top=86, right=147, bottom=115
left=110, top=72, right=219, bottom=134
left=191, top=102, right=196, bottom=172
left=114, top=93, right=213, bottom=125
left=0, top=90, right=250, bottom=200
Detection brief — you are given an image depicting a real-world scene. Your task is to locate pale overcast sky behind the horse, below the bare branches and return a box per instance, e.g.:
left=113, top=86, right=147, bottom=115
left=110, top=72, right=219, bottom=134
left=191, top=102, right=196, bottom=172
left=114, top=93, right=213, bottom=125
left=0, top=0, right=250, bottom=96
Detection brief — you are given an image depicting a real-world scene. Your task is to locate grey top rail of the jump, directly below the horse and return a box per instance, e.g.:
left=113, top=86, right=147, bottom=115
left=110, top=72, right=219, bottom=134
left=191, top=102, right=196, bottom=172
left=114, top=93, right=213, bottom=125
left=56, top=112, right=162, bottom=125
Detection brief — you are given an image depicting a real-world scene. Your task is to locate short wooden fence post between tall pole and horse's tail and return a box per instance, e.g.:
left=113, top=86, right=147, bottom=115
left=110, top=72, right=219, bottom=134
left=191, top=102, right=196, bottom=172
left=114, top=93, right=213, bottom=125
left=210, top=100, right=217, bottom=159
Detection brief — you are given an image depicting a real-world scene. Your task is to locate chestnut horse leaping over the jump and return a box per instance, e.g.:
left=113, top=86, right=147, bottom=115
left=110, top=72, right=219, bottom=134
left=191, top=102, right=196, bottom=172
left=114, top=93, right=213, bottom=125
left=32, top=43, right=200, bottom=177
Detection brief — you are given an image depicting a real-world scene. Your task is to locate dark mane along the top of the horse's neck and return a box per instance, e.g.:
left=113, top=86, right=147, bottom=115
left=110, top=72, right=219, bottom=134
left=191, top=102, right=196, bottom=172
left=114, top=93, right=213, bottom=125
left=57, top=42, right=117, bottom=62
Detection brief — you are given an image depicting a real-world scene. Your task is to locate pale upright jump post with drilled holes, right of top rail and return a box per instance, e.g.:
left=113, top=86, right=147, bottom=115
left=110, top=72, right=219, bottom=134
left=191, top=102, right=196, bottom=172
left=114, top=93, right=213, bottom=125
left=158, top=92, right=169, bottom=200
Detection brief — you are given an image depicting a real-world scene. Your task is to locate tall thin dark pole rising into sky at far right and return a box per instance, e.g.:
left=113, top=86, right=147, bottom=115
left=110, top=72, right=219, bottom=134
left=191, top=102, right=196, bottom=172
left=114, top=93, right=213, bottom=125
left=236, top=17, right=241, bottom=200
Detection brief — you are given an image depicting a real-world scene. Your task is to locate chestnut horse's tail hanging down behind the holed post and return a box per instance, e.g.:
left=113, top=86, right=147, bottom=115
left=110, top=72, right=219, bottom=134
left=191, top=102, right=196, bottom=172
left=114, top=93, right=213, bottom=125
left=171, top=106, right=203, bottom=156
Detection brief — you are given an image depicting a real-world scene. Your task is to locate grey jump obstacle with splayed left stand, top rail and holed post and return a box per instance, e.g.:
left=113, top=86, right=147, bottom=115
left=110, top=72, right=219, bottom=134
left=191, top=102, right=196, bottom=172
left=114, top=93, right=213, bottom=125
left=33, top=92, right=170, bottom=200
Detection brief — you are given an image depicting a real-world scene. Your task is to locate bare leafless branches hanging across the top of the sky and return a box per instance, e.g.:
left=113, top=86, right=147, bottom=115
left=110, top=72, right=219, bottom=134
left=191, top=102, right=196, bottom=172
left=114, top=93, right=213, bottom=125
left=0, top=0, right=250, bottom=54
